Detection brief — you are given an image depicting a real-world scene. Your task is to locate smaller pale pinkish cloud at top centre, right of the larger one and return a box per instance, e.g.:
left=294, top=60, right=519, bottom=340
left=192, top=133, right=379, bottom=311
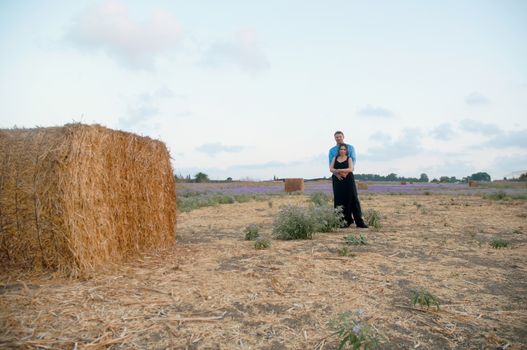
left=201, top=30, right=271, bottom=74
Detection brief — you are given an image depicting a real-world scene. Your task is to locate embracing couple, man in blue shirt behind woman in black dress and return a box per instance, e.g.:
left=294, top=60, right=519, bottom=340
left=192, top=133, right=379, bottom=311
left=329, top=131, right=368, bottom=228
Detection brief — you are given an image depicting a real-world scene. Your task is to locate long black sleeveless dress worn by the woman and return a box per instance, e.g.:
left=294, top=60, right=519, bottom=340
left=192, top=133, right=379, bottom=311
left=332, top=157, right=362, bottom=226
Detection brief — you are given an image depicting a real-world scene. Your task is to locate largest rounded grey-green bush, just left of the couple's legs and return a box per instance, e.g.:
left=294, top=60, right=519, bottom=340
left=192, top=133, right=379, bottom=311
left=273, top=205, right=315, bottom=240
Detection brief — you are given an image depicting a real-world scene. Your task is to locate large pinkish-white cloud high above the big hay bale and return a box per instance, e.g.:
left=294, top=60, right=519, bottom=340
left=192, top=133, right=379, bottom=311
left=66, top=0, right=181, bottom=69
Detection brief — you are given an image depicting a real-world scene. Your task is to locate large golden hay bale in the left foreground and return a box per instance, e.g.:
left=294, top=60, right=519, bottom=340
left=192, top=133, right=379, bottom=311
left=0, top=124, right=176, bottom=275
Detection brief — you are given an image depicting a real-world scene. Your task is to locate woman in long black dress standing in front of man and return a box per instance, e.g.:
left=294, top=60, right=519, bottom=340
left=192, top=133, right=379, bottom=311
left=330, top=144, right=368, bottom=228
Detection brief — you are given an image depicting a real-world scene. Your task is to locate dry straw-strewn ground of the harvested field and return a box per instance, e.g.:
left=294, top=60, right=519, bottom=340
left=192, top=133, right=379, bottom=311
left=0, top=195, right=527, bottom=349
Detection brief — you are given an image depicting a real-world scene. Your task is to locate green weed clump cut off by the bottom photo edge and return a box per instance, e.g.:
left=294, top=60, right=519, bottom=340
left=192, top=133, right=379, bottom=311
left=329, top=309, right=379, bottom=350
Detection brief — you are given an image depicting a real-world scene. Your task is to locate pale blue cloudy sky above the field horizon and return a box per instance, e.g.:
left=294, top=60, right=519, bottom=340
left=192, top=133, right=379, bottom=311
left=0, top=0, right=527, bottom=180
